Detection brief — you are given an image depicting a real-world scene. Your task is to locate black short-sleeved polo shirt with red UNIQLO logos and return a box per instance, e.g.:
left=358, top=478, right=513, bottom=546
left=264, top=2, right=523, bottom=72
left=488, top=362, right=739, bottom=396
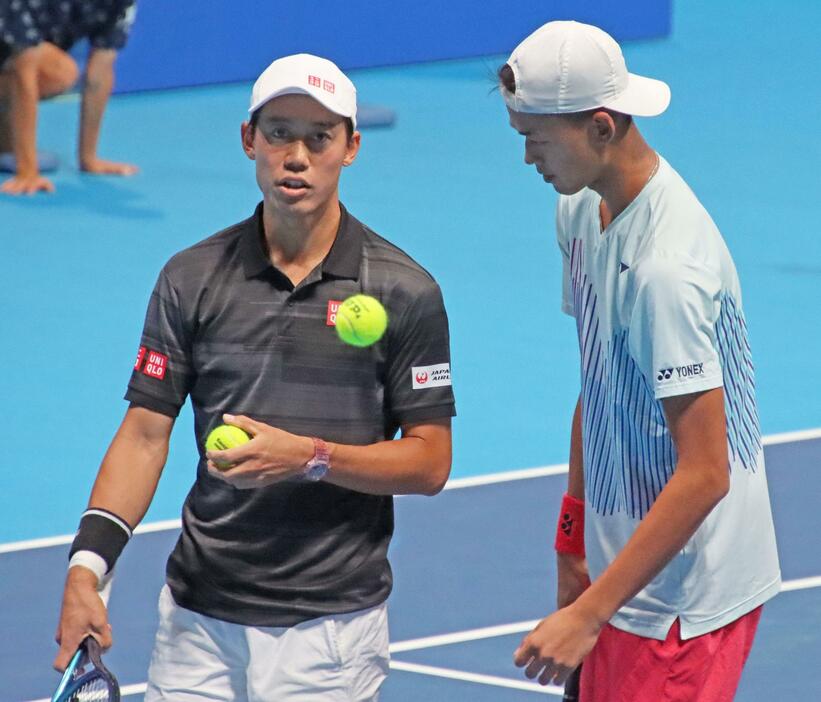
left=126, top=205, right=455, bottom=626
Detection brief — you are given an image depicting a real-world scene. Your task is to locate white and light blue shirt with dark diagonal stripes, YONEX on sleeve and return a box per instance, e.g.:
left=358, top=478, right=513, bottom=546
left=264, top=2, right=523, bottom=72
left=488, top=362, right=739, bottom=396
left=557, top=159, right=780, bottom=639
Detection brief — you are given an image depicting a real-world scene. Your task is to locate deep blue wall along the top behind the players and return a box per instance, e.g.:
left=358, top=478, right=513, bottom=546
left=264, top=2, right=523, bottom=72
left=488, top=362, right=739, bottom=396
left=112, top=0, right=672, bottom=92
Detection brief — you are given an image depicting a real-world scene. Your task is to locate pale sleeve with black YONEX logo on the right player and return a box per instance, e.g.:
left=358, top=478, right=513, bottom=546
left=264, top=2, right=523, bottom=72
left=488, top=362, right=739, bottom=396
left=629, top=254, right=723, bottom=399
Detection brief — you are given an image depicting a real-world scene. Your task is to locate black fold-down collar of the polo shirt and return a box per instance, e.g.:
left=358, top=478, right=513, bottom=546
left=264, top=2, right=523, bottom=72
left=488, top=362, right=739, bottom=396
left=240, top=202, right=362, bottom=280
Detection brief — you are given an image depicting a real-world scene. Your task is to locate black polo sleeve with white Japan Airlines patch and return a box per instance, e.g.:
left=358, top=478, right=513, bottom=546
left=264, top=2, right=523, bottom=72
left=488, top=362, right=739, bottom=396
left=385, top=284, right=456, bottom=426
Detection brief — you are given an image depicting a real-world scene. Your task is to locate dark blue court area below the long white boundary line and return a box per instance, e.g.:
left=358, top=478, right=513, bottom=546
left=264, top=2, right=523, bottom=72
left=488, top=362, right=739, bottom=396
left=0, top=438, right=821, bottom=702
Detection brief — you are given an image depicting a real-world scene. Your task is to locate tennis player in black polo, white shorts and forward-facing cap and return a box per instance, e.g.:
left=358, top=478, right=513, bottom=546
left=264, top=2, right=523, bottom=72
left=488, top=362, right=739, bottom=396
left=55, top=54, right=455, bottom=702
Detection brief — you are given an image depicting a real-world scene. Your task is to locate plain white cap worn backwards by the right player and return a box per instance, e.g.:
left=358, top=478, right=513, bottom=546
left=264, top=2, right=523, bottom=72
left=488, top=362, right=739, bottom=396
left=502, top=21, right=670, bottom=117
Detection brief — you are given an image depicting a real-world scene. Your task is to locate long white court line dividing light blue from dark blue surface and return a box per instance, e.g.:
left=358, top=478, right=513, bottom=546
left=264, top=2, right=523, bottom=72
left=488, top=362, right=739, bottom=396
left=0, top=427, right=821, bottom=553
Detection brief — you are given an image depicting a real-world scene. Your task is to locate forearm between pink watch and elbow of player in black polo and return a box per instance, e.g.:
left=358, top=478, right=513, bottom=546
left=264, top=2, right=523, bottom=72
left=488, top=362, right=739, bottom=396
left=324, top=421, right=451, bottom=495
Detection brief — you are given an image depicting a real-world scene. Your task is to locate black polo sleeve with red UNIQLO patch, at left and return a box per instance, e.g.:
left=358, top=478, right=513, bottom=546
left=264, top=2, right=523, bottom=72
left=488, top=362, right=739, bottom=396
left=125, top=270, right=194, bottom=417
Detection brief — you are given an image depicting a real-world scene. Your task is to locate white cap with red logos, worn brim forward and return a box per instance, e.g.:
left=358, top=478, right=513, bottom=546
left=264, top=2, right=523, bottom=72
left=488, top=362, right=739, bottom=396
left=248, top=54, right=356, bottom=129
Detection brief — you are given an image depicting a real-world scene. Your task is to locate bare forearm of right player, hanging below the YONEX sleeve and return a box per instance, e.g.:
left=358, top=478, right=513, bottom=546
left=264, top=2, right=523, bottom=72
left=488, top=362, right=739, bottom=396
left=577, top=461, right=727, bottom=624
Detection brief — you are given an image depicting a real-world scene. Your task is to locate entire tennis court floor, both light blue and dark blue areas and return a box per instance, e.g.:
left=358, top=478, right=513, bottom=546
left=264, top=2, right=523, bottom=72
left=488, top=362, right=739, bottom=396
left=0, top=0, right=821, bottom=702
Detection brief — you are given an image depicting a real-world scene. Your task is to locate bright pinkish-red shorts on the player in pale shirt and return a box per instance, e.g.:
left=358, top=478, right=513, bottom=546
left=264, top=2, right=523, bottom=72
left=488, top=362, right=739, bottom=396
left=579, top=607, right=761, bottom=702
